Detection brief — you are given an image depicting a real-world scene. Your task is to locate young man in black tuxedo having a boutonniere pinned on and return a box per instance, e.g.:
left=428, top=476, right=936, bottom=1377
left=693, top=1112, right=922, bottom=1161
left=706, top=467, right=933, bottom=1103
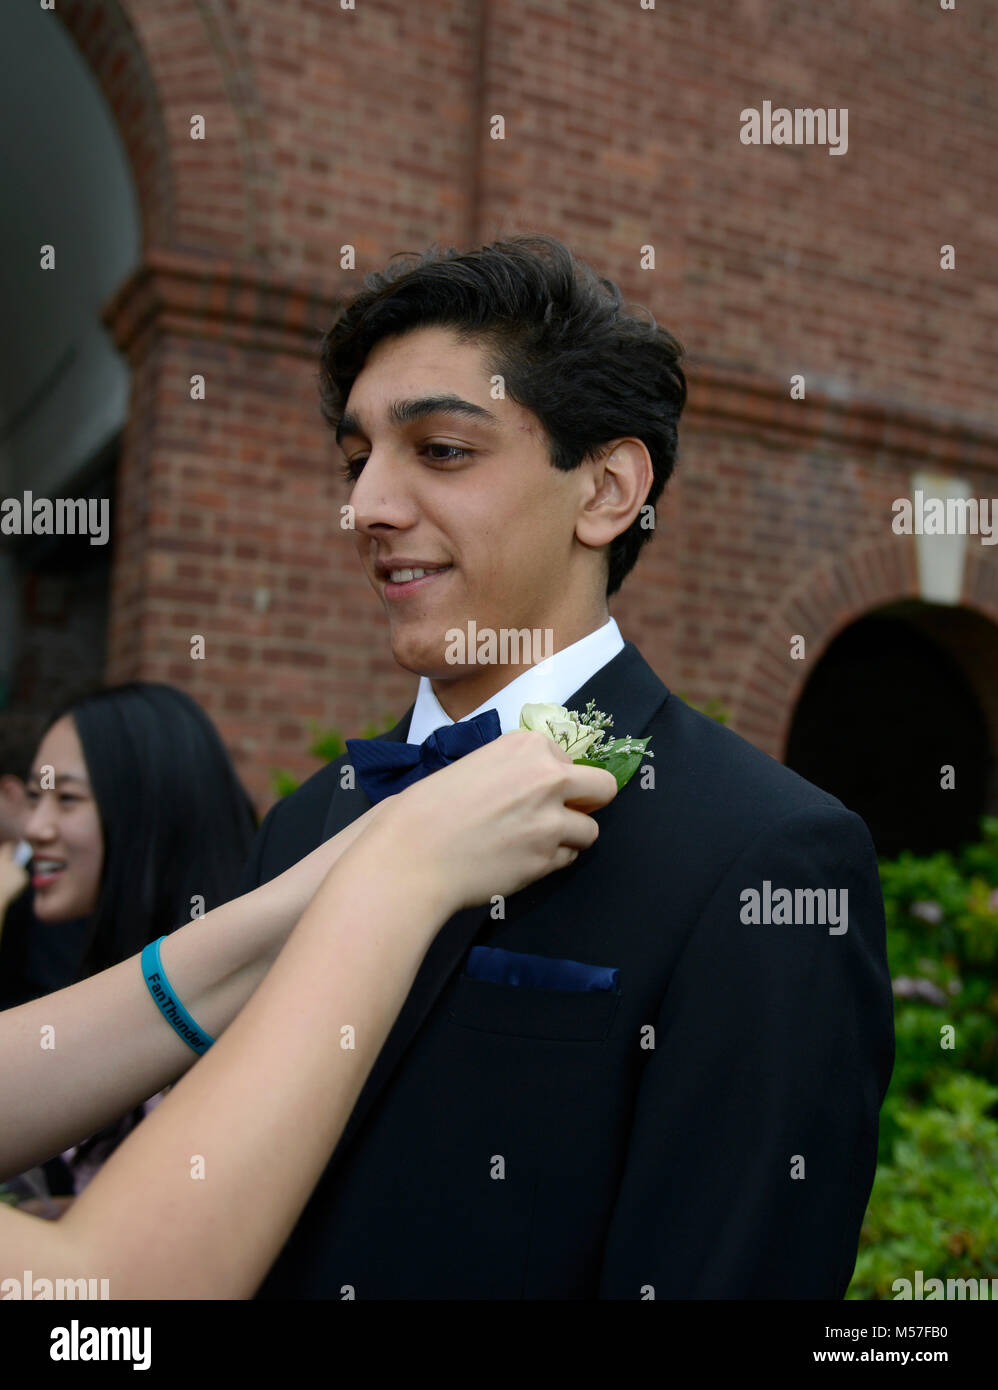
left=240, top=238, right=894, bottom=1300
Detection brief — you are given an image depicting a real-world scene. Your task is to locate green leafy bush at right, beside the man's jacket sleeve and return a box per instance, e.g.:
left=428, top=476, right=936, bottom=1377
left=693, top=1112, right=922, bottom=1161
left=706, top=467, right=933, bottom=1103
left=846, top=817, right=998, bottom=1298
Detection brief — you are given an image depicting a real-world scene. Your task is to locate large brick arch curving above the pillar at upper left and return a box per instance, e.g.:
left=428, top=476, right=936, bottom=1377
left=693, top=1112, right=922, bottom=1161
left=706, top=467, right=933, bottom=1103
left=57, top=0, right=267, bottom=260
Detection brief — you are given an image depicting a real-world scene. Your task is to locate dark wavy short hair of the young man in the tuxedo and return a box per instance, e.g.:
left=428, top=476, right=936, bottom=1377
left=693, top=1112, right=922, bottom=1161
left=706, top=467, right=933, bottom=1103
left=320, top=234, right=687, bottom=598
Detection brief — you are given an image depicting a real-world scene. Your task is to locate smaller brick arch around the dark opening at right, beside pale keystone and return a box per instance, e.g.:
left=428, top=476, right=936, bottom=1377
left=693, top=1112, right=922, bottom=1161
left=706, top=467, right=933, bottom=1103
left=731, top=535, right=998, bottom=759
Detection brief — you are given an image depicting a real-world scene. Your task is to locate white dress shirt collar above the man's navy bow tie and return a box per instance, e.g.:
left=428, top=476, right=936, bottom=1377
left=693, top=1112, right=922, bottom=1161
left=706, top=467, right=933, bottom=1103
left=406, top=619, right=624, bottom=744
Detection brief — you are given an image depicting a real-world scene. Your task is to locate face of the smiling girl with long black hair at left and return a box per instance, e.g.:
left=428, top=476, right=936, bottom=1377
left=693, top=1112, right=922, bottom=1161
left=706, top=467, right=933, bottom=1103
left=24, top=714, right=104, bottom=922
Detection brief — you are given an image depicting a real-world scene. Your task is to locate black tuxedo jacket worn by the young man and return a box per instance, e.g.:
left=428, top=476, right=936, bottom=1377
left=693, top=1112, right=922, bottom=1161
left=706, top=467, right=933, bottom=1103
left=240, top=642, right=894, bottom=1300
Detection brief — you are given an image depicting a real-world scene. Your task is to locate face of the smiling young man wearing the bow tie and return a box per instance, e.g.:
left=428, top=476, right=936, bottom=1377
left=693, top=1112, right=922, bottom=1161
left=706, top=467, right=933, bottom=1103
left=339, top=327, right=605, bottom=695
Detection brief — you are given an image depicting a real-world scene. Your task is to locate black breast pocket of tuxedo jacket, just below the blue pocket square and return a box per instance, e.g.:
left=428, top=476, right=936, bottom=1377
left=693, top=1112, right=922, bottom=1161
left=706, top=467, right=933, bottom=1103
left=448, top=974, right=620, bottom=1043
